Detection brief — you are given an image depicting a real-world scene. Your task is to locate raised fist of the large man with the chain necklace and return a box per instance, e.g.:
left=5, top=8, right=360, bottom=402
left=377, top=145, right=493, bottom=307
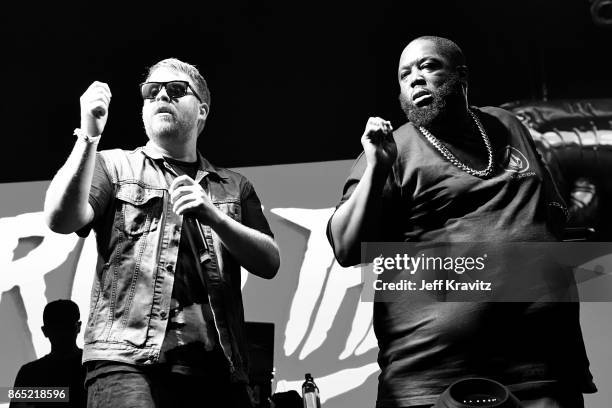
left=361, top=117, right=397, bottom=169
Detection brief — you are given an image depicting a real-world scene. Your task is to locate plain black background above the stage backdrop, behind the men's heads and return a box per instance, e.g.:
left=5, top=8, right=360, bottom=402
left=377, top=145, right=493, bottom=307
left=0, top=0, right=612, bottom=182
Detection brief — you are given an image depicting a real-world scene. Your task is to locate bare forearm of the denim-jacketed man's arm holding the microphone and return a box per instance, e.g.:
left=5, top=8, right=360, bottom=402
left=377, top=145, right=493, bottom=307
left=211, top=213, right=280, bottom=279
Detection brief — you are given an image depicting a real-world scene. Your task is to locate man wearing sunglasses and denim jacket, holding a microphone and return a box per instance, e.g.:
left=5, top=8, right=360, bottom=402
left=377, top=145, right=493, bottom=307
left=45, top=59, right=279, bottom=407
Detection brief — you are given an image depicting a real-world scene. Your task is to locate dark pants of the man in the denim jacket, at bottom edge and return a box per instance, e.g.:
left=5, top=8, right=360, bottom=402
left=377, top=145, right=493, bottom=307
left=87, top=370, right=251, bottom=408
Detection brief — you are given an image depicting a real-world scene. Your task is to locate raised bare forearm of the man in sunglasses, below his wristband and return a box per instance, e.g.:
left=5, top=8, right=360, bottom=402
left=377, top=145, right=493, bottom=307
left=44, top=138, right=97, bottom=234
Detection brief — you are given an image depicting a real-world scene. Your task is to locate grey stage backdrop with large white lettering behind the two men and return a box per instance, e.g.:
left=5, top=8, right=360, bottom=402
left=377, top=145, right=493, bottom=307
left=0, top=161, right=612, bottom=408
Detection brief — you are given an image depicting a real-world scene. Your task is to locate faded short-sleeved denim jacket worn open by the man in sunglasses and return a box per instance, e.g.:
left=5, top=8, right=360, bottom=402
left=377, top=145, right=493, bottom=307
left=79, top=142, right=271, bottom=382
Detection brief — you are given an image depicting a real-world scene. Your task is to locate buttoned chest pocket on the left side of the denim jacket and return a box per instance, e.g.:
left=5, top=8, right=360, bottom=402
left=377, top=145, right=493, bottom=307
left=115, top=183, right=164, bottom=238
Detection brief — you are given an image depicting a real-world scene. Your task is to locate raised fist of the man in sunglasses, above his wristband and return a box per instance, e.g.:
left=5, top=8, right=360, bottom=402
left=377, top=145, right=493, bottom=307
left=80, top=81, right=112, bottom=136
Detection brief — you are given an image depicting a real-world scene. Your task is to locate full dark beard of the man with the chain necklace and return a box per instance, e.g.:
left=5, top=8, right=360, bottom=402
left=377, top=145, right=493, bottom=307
left=399, top=74, right=464, bottom=128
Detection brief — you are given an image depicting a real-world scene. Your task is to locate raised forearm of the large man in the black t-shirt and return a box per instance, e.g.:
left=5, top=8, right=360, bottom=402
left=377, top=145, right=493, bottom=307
left=331, top=165, right=388, bottom=266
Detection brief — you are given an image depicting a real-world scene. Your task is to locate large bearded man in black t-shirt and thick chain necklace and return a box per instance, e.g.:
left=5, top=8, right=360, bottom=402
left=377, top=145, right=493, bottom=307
left=328, top=36, right=595, bottom=408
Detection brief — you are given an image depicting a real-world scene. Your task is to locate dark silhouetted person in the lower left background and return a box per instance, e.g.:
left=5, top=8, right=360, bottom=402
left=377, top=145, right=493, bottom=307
left=10, top=299, right=86, bottom=408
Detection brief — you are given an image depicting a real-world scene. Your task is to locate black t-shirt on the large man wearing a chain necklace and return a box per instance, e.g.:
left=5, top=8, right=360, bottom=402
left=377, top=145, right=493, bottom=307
left=328, top=108, right=594, bottom=407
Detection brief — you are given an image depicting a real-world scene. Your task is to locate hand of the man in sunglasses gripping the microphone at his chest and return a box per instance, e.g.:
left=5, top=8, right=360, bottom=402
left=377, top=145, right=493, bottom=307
left=170, top=175, right=221, bottom=226
